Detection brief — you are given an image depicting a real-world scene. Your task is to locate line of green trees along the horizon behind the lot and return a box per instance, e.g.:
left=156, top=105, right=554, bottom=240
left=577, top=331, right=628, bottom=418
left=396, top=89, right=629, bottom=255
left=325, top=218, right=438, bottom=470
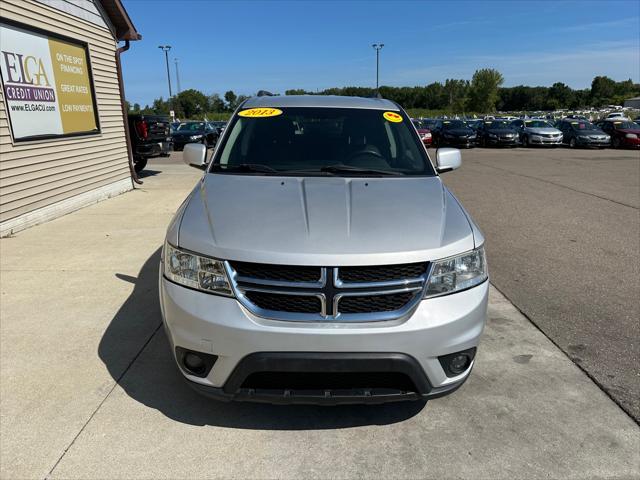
left=130, top=68, right=640, bottom=118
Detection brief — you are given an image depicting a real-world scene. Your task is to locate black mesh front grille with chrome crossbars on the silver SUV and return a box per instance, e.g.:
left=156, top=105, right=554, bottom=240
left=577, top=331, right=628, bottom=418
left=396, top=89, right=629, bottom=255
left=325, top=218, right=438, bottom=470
left=227, top=261, right=429, bottom=322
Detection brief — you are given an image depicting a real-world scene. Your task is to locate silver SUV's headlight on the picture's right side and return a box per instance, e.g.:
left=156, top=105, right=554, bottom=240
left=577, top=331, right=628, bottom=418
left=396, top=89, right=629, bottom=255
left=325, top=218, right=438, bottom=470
left=425, top=247, right=488, bottom=297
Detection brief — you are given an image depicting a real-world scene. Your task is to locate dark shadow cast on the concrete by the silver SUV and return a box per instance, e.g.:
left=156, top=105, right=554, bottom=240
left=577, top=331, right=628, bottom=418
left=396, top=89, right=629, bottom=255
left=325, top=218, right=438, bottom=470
left=98, top=249, right=426, bottom=430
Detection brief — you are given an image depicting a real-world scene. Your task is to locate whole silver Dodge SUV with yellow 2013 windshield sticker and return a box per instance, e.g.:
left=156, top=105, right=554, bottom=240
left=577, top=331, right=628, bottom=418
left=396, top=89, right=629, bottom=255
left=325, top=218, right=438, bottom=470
left=160, top=95, right=489, bottom=404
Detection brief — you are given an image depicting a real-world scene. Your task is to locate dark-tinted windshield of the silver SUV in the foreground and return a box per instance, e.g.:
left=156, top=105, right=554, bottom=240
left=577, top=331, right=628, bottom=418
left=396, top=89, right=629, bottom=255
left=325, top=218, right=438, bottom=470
left=211, top=107, right=435, bottom=176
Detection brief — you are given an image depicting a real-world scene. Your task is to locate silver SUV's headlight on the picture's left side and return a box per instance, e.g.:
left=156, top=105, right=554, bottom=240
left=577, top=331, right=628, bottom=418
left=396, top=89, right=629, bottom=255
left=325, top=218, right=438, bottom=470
left=163, top=243, right=233, bottom=296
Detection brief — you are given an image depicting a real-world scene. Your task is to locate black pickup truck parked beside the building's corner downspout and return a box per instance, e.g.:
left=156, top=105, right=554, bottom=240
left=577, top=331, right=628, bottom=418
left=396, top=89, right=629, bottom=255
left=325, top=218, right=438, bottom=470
left=128, top=114, right=171, bottom=173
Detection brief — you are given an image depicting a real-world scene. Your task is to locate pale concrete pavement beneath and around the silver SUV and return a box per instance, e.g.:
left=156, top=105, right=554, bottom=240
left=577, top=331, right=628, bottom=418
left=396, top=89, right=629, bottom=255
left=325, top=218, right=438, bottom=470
left=0, top=156, right=640, bottom=479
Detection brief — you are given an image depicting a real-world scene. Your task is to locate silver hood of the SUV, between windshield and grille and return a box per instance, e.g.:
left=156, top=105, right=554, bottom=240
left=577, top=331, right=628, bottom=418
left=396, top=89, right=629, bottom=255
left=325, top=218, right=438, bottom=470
left=176, top=174, right=474, bottom=266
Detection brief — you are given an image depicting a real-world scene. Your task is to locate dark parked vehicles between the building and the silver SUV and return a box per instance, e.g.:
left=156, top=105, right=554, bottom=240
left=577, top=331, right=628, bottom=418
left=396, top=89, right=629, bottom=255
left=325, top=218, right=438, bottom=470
left=129, top=114, right=227, bottom=172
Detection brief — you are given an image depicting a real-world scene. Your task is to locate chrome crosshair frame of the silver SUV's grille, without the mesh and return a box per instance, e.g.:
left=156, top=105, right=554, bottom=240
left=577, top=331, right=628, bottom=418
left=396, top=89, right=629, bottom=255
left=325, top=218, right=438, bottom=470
left=225, top=261, right=432, bottom=323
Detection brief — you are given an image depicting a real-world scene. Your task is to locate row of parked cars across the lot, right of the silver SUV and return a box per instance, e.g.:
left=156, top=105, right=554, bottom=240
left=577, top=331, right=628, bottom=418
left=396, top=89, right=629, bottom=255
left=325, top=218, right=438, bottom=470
left=413, top=117, right=640, bottom=148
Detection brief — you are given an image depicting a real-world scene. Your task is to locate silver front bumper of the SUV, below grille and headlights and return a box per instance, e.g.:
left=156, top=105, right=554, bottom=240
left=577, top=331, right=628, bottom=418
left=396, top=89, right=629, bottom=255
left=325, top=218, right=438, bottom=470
left=160, top=276, right=489, bottom=403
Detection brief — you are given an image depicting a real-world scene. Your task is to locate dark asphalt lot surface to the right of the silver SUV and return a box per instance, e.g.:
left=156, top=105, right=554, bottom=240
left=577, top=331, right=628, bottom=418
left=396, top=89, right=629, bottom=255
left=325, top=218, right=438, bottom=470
left=440, top=148, right=640, bottom=421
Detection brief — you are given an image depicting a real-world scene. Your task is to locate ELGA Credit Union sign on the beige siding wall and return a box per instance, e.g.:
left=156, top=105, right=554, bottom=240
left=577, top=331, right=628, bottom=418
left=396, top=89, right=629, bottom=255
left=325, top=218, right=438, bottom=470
left=0, top=23, right=99, bottom=141
